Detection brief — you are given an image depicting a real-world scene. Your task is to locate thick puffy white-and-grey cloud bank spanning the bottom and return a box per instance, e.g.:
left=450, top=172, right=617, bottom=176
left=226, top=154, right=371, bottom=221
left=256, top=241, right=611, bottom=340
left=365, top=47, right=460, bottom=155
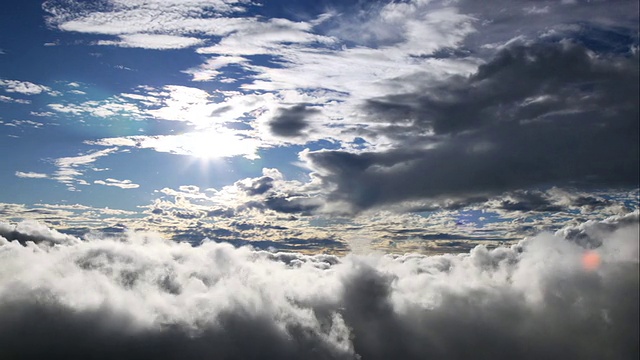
left=0, top=214, right=639, bottom=359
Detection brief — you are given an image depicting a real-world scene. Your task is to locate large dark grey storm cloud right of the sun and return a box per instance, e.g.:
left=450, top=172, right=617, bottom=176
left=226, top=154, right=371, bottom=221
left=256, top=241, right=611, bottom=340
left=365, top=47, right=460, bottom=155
left=306, top=43, right=639, bottom=210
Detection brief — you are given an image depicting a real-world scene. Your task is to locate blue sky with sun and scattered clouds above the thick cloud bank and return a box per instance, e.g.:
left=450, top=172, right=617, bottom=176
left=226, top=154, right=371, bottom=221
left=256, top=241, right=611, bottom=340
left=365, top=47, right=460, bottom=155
left=0, top=0, right=638, bottom=252
